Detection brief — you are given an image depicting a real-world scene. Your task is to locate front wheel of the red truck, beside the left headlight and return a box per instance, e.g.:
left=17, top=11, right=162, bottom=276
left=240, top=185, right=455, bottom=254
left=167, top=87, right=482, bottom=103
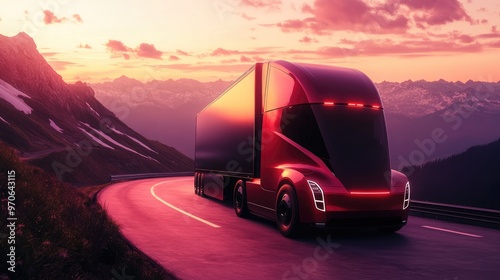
left=276, top=184, right=300, bottom=237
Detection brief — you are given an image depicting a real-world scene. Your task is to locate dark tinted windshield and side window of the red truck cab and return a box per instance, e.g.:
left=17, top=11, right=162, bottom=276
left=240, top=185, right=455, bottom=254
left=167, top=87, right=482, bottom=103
left=283, top=104, right=390, bottom=190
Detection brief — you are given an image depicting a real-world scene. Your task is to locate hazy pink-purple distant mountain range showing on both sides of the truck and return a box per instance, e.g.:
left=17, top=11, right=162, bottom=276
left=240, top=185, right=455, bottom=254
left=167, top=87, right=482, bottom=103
left=91, top=72, right=500, bottom=168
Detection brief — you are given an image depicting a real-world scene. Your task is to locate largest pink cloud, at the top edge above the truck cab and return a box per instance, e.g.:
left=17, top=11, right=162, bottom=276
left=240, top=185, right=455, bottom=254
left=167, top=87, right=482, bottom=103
left=276, top=0, right=475, bottom=35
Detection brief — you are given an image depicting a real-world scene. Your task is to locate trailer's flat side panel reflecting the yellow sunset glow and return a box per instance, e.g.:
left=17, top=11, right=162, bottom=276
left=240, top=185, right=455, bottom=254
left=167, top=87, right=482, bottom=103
left=195, top=69, right=256, bottom=177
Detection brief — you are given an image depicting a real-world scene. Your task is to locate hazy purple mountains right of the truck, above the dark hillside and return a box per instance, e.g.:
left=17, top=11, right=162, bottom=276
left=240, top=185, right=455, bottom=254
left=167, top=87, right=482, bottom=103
left=376, top=80, right=500, bottom=169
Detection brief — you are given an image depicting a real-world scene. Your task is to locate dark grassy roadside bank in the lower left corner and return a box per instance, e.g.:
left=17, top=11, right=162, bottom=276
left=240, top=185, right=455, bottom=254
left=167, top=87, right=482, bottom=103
left=0, top=143, right=177, bottom=280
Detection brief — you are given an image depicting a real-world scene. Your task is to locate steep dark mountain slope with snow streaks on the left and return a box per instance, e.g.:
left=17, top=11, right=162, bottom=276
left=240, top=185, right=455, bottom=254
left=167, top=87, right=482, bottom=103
left=0, top=33, right=193, bottom=185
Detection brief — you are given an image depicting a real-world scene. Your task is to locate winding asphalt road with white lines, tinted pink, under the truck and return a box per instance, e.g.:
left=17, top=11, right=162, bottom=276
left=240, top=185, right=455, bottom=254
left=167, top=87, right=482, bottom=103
left=98, top=177, right=500, bottom=280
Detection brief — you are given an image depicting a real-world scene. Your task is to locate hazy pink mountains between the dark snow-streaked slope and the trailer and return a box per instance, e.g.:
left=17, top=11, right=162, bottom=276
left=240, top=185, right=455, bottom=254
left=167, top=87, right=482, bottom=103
left=91, top=76, right=231, bottom=158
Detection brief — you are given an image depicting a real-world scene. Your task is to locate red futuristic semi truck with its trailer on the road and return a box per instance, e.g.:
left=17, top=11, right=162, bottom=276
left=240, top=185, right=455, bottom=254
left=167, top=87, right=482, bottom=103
left=194, top=61, right=410, bottom=237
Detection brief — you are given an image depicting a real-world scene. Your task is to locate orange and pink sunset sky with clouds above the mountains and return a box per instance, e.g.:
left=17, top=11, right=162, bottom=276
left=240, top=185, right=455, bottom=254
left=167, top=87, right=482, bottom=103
left=0, top=0, right=500, bottom=83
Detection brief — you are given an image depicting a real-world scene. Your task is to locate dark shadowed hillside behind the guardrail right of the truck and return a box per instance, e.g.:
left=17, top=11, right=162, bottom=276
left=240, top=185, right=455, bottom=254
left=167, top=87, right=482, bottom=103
left=403, top=139, right=500, bottom=210
